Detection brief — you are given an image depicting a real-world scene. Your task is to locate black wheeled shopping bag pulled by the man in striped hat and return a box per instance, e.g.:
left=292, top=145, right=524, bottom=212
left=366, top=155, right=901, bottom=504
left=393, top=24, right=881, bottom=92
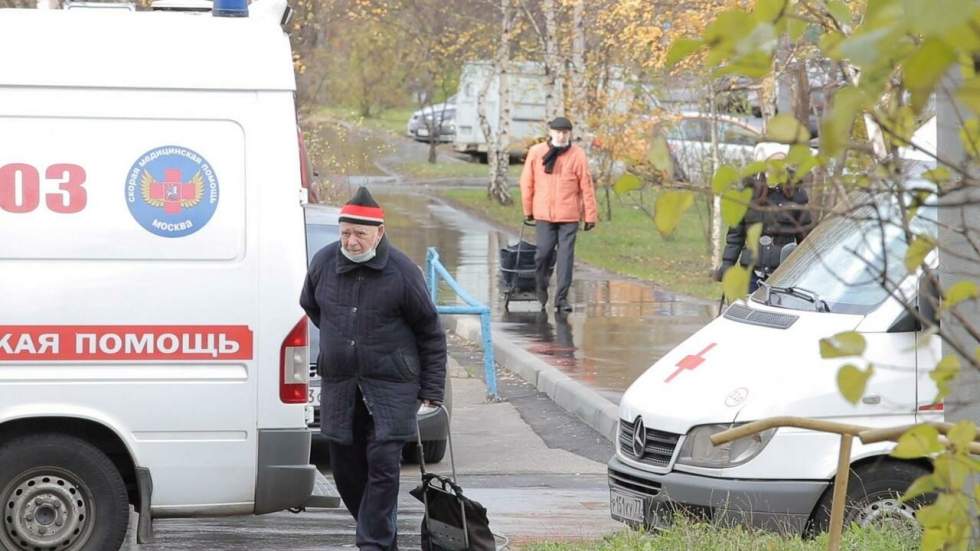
left=411, top=406, right=497, bottom=551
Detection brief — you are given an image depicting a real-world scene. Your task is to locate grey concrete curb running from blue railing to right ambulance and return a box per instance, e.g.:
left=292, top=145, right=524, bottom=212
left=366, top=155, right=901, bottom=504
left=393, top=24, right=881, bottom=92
left=443, top=316, right=619, bottom=442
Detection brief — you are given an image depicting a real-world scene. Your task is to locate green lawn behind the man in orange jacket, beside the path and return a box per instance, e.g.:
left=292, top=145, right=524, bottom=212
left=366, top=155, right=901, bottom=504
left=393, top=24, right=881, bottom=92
left=441, top=189, right=721, bottom=299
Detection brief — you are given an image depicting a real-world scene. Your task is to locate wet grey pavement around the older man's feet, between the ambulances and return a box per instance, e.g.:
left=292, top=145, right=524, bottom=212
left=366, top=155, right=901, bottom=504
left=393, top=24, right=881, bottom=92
left=123, top=352, right=622, bottom=551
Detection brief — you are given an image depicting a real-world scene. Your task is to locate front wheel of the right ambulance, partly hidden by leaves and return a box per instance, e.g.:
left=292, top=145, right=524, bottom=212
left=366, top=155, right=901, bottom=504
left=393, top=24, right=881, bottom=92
left=810, top=460, right=935, bottom=534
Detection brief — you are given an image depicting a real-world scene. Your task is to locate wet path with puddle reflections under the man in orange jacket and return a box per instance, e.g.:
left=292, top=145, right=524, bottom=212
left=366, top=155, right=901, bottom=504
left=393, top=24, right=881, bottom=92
left=374, top=188, right=716, bottom=403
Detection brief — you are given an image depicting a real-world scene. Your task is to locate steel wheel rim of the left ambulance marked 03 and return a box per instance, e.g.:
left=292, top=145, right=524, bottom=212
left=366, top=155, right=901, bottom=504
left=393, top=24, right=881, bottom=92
left=0, top=467, right=95, bottom=551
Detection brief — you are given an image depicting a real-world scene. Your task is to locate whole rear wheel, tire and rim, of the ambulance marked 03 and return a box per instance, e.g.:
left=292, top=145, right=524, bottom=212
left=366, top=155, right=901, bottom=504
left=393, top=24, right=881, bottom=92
left=0, top=433, right=129, bottom=551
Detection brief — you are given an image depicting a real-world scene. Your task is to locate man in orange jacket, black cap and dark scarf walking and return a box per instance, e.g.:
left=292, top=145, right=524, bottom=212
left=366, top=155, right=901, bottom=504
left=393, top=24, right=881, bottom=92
left=521, top=117, right=598, bottom=312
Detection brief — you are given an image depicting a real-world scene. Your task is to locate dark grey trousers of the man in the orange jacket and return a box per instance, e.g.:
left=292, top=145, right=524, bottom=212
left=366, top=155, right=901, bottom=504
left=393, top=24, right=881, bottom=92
left=534, top=220, right=578, bottom=306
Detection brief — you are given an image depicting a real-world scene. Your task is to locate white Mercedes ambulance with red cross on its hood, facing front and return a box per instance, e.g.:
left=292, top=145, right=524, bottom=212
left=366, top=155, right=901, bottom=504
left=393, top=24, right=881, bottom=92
left=609, top=187, right=942, bottom=534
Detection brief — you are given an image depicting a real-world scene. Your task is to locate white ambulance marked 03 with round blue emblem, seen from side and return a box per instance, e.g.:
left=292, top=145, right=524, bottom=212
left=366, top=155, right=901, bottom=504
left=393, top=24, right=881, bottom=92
left=0, top=4, right=315, bottom=551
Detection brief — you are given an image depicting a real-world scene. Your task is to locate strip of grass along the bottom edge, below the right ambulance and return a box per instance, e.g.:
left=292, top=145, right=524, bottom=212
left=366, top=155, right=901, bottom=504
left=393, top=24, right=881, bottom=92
left=523, top=521, right=919, bottom=551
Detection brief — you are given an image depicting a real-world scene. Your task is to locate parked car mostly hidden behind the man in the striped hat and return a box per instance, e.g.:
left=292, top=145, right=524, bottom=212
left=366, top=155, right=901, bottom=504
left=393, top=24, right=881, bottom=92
left=305, top=204, right=453, bottom=463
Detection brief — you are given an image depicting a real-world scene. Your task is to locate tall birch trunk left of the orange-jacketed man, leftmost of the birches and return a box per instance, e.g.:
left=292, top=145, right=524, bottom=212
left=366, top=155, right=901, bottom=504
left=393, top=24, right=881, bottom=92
left=481, top=0, right=515, bottom=205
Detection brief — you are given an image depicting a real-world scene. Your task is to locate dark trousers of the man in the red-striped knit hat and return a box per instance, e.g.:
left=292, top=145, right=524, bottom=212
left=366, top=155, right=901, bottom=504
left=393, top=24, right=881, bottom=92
left=330, top=390, right=405, bottom=551
